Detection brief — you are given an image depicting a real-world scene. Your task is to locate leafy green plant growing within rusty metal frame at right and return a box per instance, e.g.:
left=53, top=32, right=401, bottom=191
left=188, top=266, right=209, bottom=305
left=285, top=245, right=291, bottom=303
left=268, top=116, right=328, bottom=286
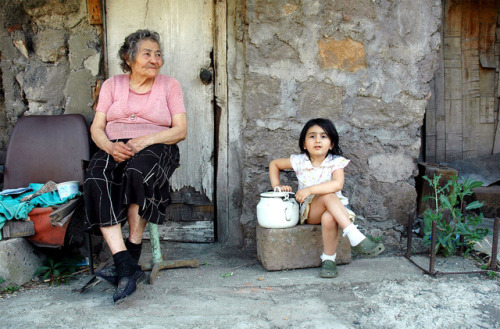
left=423, top=175, right=489, bottom=257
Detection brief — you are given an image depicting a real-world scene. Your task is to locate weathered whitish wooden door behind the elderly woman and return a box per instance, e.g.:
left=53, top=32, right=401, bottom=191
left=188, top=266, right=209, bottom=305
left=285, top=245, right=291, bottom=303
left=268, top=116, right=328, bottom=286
left=105, top=0, right=215, bottom=242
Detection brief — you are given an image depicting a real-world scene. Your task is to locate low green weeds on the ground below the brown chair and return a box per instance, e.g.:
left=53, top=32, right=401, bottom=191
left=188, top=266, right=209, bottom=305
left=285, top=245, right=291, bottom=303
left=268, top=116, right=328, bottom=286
left=35, top=257, right=78, bottom=285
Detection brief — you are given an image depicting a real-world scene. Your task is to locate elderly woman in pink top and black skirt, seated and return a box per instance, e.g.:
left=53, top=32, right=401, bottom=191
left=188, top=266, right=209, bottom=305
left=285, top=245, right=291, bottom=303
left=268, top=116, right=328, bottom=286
left=84, top=30, right=187, bottom=303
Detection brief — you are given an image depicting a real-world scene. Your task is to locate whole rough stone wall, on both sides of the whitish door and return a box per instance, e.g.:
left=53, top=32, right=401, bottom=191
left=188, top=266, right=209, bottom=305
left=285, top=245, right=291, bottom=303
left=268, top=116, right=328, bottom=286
left=0, top=0, right=441, bottom=247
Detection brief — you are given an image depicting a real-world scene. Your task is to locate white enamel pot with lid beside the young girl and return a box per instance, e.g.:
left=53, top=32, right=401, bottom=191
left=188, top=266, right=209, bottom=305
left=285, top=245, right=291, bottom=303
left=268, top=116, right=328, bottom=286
left=257, top=187, right=299, bottom=228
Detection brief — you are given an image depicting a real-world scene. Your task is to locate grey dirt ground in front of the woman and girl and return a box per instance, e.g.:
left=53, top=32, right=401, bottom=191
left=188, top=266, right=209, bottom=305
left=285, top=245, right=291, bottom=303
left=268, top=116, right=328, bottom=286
left=0, top=243, right=500, bottom=328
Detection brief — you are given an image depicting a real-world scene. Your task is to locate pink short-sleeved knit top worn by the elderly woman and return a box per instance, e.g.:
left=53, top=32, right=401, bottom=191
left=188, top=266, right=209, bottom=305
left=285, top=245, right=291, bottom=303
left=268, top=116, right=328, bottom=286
left=96, top=74, right=186, bottom=140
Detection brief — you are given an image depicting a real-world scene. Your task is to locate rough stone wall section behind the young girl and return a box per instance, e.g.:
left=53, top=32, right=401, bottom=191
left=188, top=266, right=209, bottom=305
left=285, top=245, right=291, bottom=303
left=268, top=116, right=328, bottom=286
left=240, top=0, right=441, bottom=245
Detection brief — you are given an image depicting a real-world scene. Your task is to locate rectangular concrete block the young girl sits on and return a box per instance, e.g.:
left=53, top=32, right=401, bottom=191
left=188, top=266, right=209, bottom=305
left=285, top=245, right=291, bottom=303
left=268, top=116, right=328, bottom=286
left=256, top=224, right=351, bottom=271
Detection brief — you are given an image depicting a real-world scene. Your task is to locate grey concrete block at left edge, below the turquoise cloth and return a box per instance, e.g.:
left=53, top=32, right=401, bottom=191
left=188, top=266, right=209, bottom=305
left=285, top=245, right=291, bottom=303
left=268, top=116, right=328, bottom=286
left=0, top=238, right=43, bottom=288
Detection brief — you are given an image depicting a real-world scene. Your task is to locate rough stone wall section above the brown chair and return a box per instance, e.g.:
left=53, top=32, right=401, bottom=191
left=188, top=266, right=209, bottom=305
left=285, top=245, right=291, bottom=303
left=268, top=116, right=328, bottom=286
left=0, top=0, right=102, bottom=151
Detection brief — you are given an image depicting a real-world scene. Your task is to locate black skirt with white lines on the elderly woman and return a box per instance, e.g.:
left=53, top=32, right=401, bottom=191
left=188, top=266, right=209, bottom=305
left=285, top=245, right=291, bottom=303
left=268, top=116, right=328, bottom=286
left=83, top=144, right=179, bottom=234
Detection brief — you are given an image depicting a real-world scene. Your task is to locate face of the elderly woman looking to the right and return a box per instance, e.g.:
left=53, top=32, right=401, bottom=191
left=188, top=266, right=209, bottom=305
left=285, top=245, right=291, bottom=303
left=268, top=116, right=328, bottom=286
left=127, top=40, right=163, bottom=79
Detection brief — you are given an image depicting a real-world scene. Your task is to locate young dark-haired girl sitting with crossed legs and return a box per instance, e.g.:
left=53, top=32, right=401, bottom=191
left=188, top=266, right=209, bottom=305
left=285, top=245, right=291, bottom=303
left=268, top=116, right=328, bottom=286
left=269, top=119, right=385, bottom=278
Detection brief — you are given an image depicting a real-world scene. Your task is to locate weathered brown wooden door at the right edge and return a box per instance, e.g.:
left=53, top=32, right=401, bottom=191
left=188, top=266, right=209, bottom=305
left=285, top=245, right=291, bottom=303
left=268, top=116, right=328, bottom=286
left=425, top=0, right=500, bottom=163
